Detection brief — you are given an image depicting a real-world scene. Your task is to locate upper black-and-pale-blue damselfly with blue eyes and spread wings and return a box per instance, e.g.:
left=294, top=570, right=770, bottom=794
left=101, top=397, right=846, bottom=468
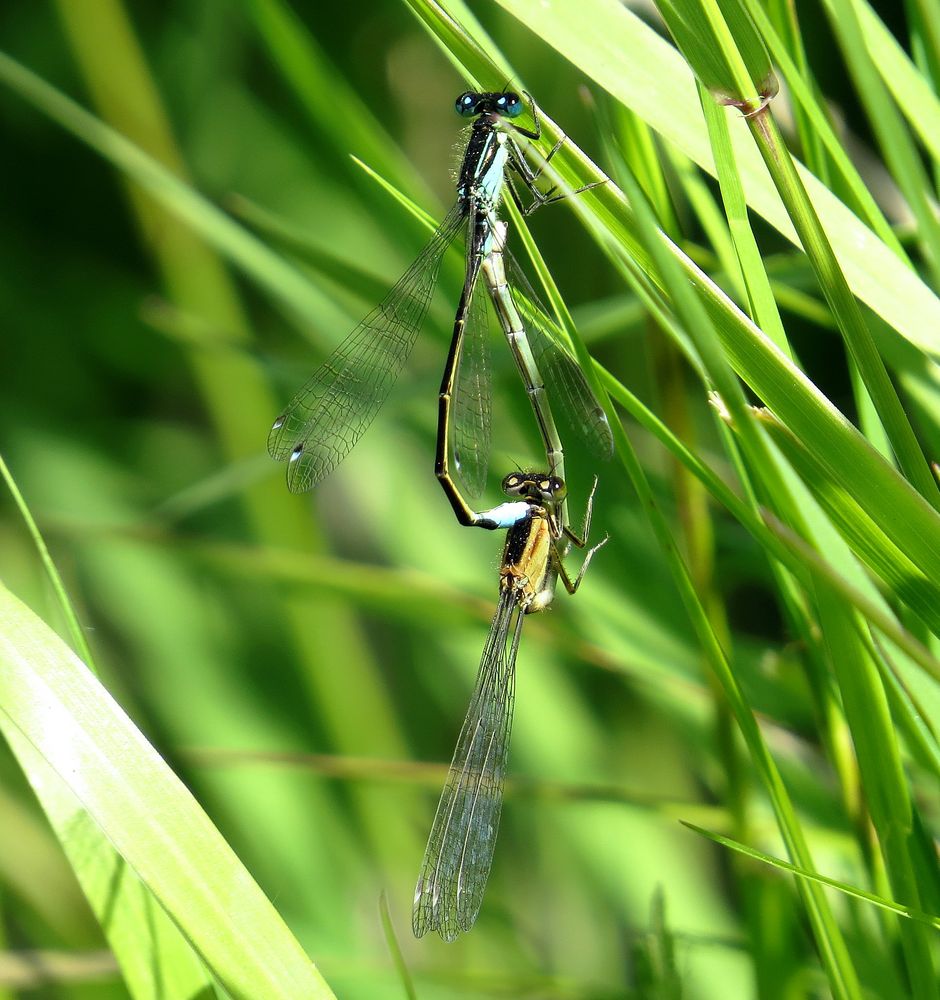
left=268, top=92, right=611, bottom=508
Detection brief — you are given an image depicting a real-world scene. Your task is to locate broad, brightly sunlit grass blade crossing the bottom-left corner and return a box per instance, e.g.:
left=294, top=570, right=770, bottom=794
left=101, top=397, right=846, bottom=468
left=0, top=589, right=333, bottom=1000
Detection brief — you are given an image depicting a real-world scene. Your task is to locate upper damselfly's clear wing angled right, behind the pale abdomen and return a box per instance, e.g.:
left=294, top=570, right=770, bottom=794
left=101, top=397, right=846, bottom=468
left=503, top=250, right=614, bottom=459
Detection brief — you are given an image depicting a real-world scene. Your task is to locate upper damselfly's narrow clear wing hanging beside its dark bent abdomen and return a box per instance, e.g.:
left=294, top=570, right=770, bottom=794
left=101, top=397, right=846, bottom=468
left=454, top=280, right=492, bottom=497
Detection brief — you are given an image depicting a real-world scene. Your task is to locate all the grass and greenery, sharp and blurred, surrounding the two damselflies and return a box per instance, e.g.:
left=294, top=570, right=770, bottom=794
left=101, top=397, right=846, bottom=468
left=0, top=0, right=940, bottom=1000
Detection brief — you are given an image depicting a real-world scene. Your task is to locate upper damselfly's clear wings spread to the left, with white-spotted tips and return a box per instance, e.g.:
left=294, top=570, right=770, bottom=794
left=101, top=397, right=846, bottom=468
left=268, top=205, right=464, bottom=493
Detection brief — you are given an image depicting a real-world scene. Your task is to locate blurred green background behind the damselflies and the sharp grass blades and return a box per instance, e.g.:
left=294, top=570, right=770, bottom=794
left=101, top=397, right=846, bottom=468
left=0, top=0, right=924, bottom=998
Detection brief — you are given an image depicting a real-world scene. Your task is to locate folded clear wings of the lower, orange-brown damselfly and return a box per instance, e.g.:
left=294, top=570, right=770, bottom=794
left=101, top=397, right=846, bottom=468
left=411, top=590, right=525, bottom=941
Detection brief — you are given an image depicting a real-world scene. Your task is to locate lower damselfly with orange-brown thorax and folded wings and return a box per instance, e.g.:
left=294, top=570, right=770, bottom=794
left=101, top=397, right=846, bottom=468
left=412, top=472, right=607, bottom=941
